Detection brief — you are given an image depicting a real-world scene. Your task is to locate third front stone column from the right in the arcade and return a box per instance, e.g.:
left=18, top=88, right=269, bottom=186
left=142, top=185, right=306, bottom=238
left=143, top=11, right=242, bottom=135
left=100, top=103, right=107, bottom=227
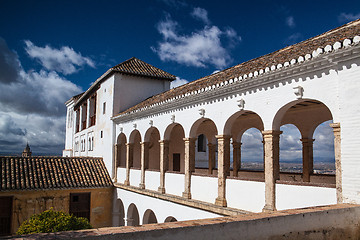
left=215, top=135, right=230, bottom=207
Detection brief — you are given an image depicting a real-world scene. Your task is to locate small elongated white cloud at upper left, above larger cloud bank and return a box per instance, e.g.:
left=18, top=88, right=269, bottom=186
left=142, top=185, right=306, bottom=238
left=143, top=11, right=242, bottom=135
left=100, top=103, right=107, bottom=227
left=25, top=40, right=95, bottom=75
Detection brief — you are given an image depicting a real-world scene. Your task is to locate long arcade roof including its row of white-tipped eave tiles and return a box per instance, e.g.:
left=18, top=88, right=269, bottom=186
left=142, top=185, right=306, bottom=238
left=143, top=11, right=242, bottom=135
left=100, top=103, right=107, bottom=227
left=114, top=19, right=360, bottom=118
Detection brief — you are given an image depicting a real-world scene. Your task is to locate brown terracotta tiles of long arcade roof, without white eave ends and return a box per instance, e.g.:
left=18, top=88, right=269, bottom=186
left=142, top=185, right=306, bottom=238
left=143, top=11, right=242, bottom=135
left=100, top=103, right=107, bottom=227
left=118, top=19, right=360, bottom=115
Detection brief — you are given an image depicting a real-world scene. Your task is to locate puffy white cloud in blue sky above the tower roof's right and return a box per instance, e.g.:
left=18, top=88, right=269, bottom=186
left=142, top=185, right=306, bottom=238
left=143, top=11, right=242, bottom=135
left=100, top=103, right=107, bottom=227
left=152, top=16, right=241, bottom=68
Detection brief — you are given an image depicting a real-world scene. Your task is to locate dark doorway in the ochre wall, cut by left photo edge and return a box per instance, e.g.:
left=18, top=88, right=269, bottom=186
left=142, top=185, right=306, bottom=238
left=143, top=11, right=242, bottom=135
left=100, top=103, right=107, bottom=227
left=0, top=197, right=13, bottom=236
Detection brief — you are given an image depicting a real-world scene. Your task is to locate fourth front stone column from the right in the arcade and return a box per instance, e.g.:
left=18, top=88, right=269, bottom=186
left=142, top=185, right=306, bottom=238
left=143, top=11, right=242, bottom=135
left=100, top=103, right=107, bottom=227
left=182, top=138, right=196, bottom=199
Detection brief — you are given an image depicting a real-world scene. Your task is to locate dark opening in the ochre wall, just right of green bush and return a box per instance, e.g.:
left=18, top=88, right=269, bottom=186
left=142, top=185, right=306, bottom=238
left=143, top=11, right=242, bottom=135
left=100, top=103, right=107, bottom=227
left=69, top=193, right=90, bottom=221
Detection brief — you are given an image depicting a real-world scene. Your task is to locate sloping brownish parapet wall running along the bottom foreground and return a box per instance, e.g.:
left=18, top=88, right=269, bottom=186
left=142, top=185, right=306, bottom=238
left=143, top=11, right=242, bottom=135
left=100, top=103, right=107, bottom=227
left=19, top=204, right=360, bottom=240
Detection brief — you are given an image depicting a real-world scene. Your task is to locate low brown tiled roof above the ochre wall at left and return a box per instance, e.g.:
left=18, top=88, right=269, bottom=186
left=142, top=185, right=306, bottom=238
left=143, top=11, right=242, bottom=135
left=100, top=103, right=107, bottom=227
left=0, top=157, right=113, bottom=191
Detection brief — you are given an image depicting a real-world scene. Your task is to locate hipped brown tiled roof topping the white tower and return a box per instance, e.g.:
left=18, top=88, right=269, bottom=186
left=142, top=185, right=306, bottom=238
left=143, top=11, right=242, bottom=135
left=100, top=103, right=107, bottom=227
left=112, top=57, right=176, bottom=81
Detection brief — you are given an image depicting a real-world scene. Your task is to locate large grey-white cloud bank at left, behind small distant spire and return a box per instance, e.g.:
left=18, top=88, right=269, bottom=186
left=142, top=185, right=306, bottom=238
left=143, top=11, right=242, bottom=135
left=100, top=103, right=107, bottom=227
left=0, top=38, right=82, bottom=154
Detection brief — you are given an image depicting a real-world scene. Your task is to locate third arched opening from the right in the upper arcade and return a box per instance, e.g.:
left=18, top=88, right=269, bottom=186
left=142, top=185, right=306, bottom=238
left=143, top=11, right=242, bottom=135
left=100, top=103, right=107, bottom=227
left=190, top=118, right=218, bottom=174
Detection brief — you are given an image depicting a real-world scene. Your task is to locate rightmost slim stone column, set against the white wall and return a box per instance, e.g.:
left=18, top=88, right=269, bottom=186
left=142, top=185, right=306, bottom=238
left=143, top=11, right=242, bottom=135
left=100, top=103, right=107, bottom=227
left=330, top=123, right=343, bottom=203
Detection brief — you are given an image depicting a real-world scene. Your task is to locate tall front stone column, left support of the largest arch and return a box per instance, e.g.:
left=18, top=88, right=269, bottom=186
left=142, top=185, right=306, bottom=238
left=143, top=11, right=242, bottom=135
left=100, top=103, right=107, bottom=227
left=262, top=130, right=282, bottom=212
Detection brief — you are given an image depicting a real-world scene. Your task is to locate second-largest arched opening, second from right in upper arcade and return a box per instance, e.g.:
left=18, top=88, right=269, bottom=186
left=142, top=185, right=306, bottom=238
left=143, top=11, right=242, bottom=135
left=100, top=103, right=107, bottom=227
left=224, top=110, right=264, bottom=179
